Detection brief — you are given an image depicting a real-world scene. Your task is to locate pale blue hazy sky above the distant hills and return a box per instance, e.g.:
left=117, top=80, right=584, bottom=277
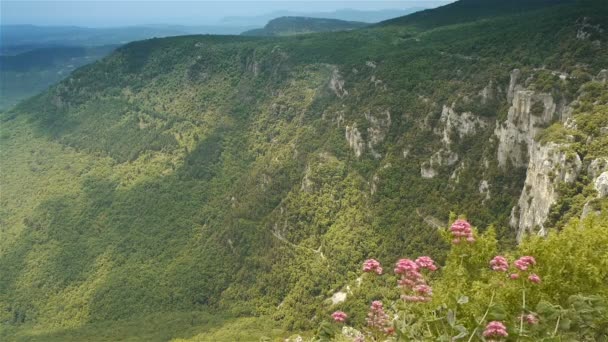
left=0, top=0, right=452, bottom=27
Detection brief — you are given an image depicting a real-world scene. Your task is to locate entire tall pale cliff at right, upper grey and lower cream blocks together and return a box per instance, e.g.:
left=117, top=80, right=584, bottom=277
left=494, top=69, right=599, bottom=241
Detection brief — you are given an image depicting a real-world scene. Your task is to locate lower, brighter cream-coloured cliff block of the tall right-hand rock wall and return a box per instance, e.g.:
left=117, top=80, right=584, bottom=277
left=511, top=143, right=582, bottom=242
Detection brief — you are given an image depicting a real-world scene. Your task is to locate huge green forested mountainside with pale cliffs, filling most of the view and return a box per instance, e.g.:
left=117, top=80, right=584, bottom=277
left=0, top=1, right=608, bottom=340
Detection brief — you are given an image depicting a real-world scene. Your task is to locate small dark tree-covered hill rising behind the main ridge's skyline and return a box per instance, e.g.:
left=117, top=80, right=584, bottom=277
left=241, top=17, right=367, bottom=37
